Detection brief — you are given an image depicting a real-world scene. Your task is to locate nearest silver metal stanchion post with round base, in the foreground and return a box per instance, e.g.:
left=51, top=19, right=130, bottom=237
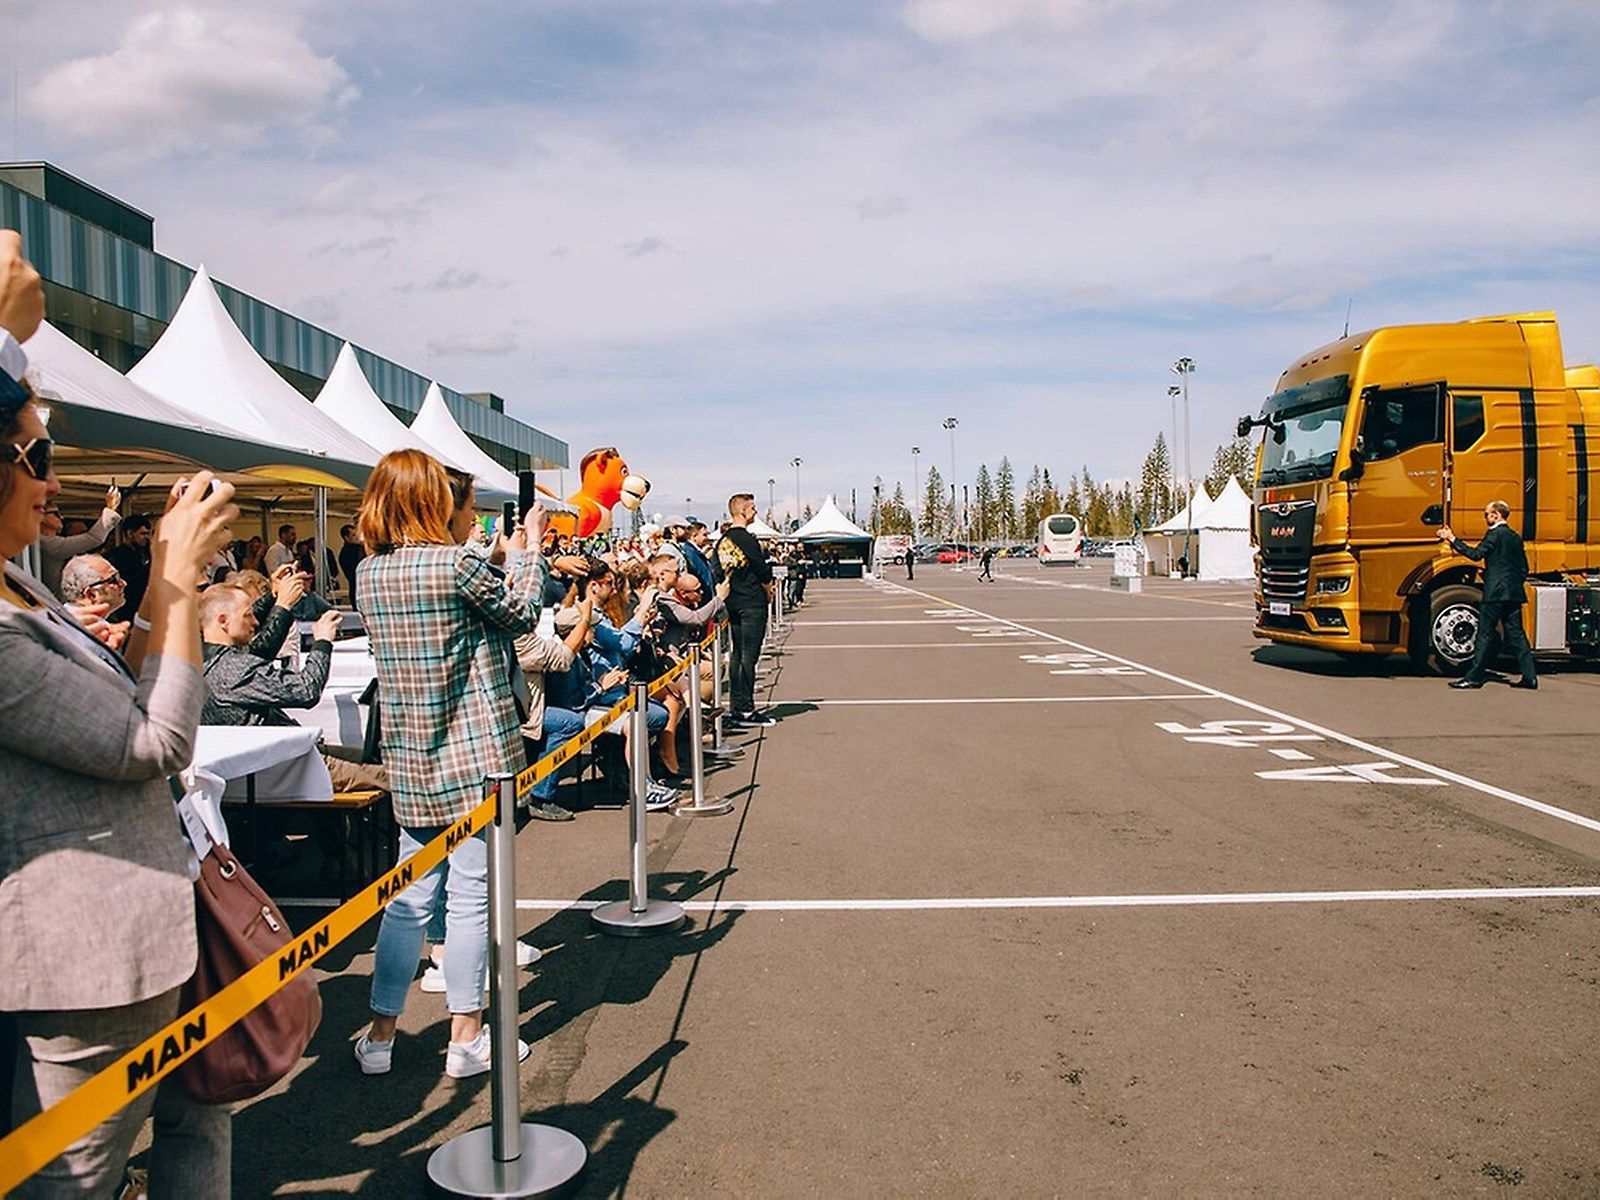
left=427, top=774, right=589, bottom=1197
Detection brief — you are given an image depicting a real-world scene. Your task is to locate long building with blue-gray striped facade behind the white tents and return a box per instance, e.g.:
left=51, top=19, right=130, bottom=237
left=0, top=163, right=568, bottom=470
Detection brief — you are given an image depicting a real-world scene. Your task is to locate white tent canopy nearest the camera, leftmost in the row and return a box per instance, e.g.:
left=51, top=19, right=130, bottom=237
left=26, top=322, right=361, bottom=486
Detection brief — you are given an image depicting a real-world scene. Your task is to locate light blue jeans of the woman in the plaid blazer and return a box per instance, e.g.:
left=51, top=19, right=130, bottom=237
left=371, top=826, right=490, bottom=1016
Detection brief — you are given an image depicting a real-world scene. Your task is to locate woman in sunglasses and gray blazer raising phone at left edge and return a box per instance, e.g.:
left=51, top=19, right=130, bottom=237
left=0, top=376, right=238, bottom=1197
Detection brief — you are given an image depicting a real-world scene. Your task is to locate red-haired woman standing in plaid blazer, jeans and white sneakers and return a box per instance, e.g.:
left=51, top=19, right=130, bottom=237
left=355, top=450, right=544, bottom=1078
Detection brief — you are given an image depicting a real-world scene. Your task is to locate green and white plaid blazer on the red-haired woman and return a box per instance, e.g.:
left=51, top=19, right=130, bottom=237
left=355, top=546, right=544, bottom=827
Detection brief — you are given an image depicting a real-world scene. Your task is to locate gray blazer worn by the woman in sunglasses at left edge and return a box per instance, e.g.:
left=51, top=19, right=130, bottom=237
left=0, top=563, right=205, bottom=1011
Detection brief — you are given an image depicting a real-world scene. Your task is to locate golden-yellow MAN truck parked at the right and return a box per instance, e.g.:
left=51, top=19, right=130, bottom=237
left=1238, top=312, right=1600, bottom=674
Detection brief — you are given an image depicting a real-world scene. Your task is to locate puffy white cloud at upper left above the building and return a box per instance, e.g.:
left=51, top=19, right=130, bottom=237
left=30, top=8, right=357, bottom=163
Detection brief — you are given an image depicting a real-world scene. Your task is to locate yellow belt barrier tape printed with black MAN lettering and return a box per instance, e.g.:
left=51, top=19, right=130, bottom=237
left=0, top=624, right=717, bottom=1195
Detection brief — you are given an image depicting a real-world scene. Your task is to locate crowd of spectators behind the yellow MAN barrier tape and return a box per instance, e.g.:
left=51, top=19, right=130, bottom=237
left=0, top=219, right=794, bottom=1195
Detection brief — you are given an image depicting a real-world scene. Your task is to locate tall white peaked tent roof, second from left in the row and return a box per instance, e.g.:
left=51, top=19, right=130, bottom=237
left=128, top=266, right=378, bottom=486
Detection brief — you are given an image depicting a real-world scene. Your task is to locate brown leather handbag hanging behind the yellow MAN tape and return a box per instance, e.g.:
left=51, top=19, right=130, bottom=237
left=176, top=845, right=322, bottom=1104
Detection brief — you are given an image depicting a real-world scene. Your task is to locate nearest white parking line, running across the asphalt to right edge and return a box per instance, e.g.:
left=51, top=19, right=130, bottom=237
left=517, top=886, right=1600, bottom=912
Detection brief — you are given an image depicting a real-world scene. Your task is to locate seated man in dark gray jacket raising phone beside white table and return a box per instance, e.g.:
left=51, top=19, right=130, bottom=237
left=200, top=584, right=389, bottom=792
